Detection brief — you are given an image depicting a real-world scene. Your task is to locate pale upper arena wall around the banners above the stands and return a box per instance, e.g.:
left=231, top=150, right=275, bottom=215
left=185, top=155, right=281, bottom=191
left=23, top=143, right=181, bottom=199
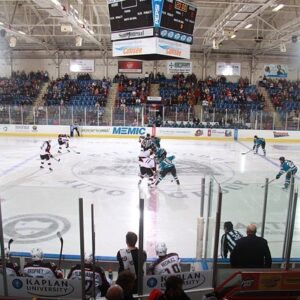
left=0, top=52, right=300, bottom=83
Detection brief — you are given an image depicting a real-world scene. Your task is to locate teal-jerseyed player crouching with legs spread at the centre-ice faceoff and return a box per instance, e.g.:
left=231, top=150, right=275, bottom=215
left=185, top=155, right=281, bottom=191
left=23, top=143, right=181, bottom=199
left=152, top=148, right=180, bottom=186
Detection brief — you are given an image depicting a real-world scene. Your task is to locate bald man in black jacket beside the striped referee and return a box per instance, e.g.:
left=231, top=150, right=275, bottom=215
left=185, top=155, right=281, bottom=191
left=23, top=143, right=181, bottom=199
left=230, top=224, right=272, bottom=268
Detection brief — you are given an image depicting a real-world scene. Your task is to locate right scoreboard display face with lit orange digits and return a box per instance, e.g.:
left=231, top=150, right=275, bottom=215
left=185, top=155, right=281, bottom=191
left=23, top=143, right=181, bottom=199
left=160, top=0, right=197, bottom=35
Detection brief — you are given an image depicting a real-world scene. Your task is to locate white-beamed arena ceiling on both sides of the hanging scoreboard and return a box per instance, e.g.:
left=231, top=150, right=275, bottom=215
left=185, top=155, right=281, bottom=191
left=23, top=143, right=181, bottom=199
left=0, top=0, right=300, bottom=56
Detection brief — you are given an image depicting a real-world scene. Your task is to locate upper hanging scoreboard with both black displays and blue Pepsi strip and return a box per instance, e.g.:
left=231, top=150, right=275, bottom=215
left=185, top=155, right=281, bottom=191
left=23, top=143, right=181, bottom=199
left=107, top=0, right=197, bottom=44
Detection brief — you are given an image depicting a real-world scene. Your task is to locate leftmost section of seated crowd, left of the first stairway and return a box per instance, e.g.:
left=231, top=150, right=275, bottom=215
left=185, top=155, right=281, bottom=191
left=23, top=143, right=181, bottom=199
left=0, top=71, right=49, bottom=105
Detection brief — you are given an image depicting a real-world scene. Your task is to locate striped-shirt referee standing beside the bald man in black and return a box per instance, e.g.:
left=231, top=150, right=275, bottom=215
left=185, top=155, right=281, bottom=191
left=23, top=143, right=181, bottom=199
left=221, top=221, right=243, bottom=258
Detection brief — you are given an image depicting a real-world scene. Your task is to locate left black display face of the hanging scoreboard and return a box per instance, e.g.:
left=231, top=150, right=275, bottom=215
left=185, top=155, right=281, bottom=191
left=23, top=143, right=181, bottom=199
left=108, top=0, right=153, bottom=32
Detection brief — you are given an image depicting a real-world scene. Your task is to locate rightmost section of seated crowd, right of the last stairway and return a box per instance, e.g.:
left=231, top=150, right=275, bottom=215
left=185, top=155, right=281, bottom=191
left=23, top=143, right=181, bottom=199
left=259, top=76, right=300, bottom=110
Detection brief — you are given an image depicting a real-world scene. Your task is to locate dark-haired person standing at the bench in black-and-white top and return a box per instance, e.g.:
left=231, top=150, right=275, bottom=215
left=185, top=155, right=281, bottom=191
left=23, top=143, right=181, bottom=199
left=117, top=231, right=147, bottom=294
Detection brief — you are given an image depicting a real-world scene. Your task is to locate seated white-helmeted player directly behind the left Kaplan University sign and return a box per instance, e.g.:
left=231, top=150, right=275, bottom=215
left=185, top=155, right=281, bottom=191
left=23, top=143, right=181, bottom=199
left=23, top=248, right=63, bottom=279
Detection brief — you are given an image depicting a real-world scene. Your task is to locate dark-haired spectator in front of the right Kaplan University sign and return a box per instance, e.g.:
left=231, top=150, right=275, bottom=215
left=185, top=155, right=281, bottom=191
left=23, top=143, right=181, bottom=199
left=156, top=275, right=190, bottom=300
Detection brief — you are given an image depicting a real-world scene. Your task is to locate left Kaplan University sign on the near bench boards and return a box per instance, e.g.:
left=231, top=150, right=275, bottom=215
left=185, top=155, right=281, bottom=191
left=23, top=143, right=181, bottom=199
left=0, top=275, right=81, bottom=299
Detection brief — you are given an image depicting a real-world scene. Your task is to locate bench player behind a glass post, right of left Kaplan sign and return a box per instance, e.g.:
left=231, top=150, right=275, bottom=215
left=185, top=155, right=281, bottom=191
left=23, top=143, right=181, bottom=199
left=68, top=253, right=110, bottom=299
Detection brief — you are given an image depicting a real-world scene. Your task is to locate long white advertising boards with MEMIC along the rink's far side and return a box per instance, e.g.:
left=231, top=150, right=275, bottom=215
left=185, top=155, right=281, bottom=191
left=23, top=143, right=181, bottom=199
left=0, top=124, right=300, bottom=142
